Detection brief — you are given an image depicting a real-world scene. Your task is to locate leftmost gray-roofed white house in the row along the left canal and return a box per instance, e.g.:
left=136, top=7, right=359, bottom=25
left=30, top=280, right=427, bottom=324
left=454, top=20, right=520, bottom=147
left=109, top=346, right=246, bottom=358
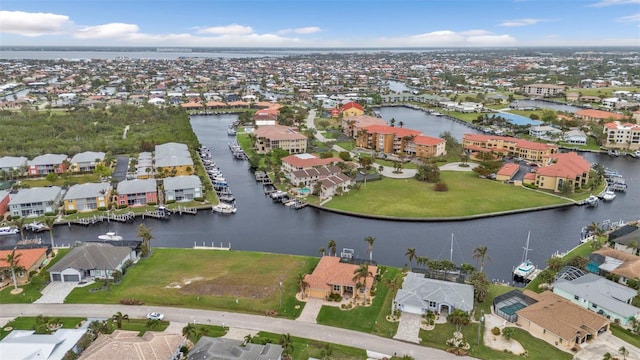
left=9, top=186, right=62, bottom=217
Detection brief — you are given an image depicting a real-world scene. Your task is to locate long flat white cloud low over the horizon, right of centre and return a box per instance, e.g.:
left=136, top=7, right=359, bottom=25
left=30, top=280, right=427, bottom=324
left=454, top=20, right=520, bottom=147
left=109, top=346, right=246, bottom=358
left=373, top=30, right=516, bottom=47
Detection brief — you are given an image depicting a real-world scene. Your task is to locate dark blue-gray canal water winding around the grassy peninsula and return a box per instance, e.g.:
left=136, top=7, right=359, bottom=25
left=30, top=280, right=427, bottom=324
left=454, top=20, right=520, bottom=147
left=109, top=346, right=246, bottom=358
left=0, top=108, right=640, bottom=281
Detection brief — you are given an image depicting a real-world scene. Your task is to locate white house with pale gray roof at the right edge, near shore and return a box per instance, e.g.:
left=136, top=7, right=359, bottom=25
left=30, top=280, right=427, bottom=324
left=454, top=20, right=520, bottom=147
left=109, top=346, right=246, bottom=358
left=553, top=273, right=640, bottom=325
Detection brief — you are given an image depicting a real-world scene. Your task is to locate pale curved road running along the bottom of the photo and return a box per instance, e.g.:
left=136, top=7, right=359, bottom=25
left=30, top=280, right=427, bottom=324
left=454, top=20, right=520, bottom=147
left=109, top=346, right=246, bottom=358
left=0, top=304, right=471, bottom=360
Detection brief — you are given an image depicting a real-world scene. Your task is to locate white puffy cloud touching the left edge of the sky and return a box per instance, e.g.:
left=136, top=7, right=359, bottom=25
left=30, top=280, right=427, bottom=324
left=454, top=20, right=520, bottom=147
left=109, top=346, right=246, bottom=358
left=0, top=11, right=73, bottom=36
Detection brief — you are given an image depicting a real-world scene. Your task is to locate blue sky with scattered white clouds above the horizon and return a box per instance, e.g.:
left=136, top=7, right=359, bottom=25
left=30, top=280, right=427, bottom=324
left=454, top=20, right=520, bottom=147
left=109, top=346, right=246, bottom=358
left=0, top=0, right=640, bottom=48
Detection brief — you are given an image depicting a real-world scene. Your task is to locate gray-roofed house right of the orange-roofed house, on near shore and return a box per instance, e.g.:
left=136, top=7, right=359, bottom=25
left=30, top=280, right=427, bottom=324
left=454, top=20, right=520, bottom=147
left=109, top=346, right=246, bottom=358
left=391, top=272, right=473, bottom=314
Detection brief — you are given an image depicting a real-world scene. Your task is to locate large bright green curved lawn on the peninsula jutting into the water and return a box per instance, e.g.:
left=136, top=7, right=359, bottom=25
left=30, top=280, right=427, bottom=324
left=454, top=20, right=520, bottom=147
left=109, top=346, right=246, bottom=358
left=324, top=171, right=569, bottom=218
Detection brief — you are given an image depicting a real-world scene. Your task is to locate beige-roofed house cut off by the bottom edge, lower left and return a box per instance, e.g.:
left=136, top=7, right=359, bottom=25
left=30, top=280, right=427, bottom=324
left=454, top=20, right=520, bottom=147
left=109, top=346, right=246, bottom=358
left=80, top=330, right=184, bottom=360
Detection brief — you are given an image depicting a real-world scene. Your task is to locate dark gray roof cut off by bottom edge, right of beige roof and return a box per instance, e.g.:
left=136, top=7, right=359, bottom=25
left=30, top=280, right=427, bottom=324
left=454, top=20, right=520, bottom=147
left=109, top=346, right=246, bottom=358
left=189, top=336, right=282, bottom=360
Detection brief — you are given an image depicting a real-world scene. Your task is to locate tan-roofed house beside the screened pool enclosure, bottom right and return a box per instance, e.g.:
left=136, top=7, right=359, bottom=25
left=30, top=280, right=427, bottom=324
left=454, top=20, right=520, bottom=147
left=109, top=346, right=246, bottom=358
left=516, top=290, right=609, bottom=350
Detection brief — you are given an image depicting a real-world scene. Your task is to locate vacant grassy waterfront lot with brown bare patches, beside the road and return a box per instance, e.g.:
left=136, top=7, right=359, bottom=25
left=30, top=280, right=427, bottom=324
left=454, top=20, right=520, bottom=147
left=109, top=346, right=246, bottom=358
left=66, top=248, right=318, bottom=318
